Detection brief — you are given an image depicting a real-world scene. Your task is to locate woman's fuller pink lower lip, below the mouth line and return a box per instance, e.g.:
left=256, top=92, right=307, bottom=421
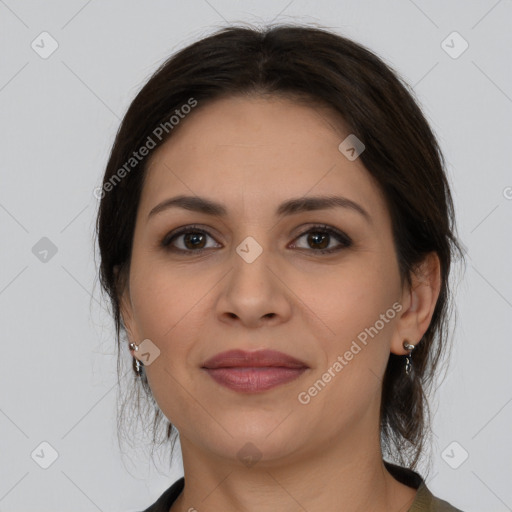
left=204, top=366, right=307, bottom=393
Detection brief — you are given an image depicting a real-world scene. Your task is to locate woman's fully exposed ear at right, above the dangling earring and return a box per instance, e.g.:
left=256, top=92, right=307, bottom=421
left=391, top=252, right=441, bottom=355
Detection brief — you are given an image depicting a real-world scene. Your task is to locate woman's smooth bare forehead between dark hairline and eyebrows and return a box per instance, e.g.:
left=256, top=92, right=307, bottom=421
left=140, top=97, right=383, bottom=222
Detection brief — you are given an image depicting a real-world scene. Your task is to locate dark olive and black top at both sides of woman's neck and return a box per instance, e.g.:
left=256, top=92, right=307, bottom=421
left=143, top=461, right=462, bottom=512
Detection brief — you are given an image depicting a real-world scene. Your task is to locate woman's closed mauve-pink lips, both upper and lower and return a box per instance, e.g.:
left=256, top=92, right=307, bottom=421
left=203, top=350, right=309, bottom=393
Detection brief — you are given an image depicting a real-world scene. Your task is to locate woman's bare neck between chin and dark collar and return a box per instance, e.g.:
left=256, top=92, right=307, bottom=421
left=171, top=414, right=416, bottom=512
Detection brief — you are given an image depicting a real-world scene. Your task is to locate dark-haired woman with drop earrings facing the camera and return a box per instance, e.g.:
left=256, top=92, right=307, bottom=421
left=97, top=26, right=460, bottom=512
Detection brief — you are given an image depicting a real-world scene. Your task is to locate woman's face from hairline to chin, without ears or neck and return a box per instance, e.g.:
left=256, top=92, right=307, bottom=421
left=122, top=97, right=412, bottom=461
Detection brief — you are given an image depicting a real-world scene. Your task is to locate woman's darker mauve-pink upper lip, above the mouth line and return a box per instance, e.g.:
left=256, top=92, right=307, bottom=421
left=203, top=350, right=308, bottom=369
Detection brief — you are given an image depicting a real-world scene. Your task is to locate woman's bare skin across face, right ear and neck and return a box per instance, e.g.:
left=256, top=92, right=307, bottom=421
left=122, top=97, right=440, bottom=512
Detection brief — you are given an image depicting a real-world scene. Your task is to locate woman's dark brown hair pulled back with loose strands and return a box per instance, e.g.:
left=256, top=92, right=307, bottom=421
left=96, top=25, right=463, bottom=468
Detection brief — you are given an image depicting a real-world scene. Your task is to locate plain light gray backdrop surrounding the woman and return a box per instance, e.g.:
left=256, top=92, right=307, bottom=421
left=0, top=0, right=512, bottom=512
